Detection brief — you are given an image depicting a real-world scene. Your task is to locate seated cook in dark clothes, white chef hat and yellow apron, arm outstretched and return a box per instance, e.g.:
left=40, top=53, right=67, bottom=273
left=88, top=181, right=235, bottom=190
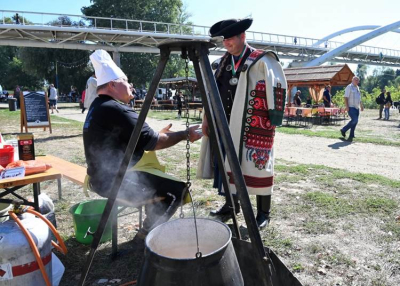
left=83, top=50, right=202, bottom=236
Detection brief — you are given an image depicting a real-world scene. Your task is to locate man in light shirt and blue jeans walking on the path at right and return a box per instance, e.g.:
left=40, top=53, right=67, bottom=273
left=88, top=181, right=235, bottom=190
left=340, top=76, right=364, bottom=142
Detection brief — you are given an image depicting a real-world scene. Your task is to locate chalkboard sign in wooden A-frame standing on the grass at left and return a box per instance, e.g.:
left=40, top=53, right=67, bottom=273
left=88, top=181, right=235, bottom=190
left=20, top=91, right=51, bottom=133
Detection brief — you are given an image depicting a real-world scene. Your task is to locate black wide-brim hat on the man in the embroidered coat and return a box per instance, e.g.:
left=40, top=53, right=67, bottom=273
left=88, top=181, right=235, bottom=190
left=209, top=18, right=253, bottom=39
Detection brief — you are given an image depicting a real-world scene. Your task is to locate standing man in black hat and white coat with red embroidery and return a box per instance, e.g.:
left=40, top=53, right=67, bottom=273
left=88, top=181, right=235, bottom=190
left=199, top=19, right=286, bottom=229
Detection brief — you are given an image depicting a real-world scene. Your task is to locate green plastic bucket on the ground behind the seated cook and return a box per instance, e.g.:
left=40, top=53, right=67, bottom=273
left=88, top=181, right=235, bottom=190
left=69, top=200, right=112, bottom=244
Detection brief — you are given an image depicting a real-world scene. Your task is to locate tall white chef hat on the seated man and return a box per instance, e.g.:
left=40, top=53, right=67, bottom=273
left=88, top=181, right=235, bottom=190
left=90, top=50, right=126, bottom=86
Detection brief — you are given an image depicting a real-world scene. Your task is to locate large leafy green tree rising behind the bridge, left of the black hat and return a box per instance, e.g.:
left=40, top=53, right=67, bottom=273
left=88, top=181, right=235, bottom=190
left=82, top=0, right=190, bottom=87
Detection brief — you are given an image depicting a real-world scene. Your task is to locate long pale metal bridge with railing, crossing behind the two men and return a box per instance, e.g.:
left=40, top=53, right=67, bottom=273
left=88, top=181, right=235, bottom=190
left=0, top=10, right=400, bottom=67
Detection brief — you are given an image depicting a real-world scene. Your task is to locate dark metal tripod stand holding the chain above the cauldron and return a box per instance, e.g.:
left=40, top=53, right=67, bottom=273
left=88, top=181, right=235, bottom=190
left=79, top=41, right=272, bottom=286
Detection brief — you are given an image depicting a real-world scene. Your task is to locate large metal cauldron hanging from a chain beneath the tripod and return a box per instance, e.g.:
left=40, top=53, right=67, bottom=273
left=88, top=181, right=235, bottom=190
left=137, top=218, right=244, bottom=286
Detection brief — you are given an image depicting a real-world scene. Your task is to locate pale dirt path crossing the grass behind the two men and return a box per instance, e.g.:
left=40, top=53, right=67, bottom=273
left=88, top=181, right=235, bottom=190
left=57, top=109, right=400, bottom=180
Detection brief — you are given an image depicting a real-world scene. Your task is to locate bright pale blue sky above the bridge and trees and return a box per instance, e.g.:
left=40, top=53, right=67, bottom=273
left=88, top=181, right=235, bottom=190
left=0, top=0, right=400, bottom=72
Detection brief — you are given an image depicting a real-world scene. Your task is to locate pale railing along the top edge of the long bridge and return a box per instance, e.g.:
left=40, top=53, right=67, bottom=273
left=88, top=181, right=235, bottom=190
left=0, top=10, right=400, bottom=57
